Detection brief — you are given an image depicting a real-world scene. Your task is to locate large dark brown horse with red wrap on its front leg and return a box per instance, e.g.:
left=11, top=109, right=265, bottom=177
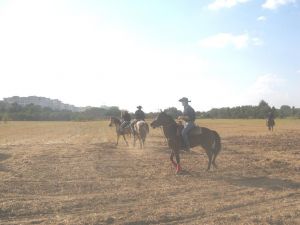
left=150, top=112, right=221, bottom=173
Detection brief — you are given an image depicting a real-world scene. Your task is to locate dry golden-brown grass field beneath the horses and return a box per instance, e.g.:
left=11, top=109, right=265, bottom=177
left=0, top=120, right=300, bottom=225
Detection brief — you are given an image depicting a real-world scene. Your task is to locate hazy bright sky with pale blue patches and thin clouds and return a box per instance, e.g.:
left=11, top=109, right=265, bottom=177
left=0, top=0, right=300, bottom=112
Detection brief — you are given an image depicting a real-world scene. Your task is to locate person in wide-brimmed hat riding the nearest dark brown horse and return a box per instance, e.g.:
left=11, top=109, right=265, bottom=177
left=178, top=97, right=196, bottom=152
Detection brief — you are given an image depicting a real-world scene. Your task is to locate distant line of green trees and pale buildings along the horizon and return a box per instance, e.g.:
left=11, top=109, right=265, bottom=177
left=0, top=100, right=300, bottom=121
